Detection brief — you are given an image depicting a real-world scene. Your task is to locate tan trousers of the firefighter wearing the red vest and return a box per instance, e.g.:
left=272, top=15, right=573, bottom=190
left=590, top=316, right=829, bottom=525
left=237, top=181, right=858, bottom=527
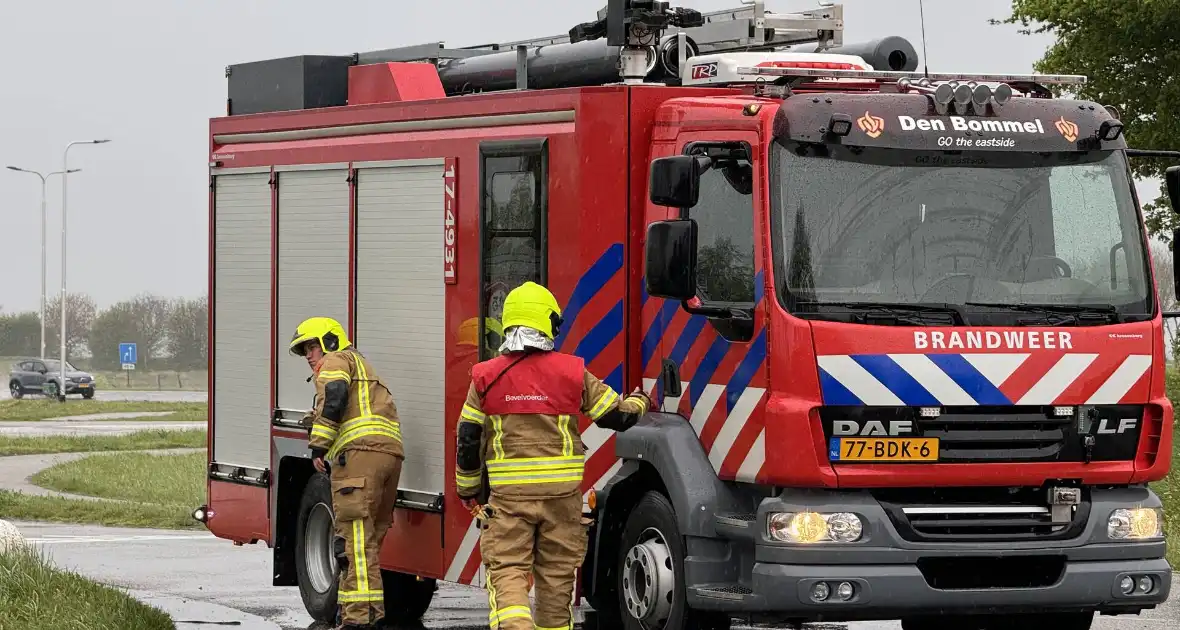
left=479, top=493, right=588, bottom=630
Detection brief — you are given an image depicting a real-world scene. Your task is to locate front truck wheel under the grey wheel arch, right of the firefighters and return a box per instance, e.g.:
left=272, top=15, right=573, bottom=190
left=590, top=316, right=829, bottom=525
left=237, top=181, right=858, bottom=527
left=616, top=492, right=729, bottom=630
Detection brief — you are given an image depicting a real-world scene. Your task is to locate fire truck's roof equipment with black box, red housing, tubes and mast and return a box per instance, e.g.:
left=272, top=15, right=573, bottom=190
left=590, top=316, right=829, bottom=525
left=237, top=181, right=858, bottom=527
left=225, top=0, right=918, bottom=116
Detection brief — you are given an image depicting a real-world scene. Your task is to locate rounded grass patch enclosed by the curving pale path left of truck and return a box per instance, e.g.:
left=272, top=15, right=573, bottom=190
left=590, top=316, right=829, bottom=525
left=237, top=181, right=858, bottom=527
left=30, top=453, right=207, bottom=509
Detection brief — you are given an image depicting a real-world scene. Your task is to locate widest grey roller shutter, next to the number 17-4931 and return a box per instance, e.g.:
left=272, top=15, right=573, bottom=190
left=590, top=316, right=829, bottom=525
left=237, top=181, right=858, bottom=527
left=356, top=159, right=446, bottom=493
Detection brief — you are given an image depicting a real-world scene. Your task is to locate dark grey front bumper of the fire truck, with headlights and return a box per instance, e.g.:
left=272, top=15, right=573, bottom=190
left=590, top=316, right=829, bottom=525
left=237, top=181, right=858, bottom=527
left=686, top=487, right=1172, bottom=621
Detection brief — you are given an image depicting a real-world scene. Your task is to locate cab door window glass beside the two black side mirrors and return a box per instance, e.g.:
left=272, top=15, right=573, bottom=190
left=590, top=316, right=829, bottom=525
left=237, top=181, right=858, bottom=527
left=686, top=143, right=755, bottom=341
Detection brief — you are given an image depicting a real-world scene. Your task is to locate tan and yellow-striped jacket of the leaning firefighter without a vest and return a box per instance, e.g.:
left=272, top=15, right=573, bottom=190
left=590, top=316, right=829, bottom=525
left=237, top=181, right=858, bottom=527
left=308, top=348, right=405, bottom=460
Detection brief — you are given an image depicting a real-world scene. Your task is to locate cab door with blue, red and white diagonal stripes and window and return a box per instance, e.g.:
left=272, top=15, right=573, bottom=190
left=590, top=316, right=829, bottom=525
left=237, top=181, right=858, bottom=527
left=643, top=131, right=767, bottom=481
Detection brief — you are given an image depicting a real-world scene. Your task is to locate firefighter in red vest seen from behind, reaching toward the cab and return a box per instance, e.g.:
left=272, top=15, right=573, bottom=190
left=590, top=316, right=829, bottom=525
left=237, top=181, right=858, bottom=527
left=455, top=282, right=651, bottom=630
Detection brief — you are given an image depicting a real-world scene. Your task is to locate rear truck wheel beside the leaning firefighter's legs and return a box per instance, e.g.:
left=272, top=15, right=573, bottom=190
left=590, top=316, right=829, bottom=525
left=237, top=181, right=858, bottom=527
left=295, top=473, right=340, bottom=624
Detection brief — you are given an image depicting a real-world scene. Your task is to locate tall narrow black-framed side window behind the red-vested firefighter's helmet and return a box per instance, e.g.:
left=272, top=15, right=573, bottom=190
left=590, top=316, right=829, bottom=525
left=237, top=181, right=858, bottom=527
left=479, top=140, right=549, bottom=361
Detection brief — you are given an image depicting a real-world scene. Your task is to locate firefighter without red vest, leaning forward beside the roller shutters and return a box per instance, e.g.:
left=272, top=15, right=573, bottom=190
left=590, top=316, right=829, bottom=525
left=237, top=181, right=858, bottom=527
left=290, top=317, right=405, bottom=630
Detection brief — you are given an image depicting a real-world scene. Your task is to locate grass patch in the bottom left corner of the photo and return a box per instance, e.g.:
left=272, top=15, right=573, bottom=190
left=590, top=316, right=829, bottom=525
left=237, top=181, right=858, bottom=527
left=0, top=547, right=176, bottom=630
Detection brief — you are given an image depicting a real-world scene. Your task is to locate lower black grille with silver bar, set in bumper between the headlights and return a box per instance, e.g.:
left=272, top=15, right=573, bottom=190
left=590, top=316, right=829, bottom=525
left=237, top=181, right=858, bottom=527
left=873, top=488, right=1089, bottom=543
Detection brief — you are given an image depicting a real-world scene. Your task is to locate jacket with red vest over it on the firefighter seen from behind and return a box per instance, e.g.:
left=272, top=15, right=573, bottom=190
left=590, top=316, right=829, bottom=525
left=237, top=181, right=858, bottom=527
left=455, top=352, right=650, bottom=499
